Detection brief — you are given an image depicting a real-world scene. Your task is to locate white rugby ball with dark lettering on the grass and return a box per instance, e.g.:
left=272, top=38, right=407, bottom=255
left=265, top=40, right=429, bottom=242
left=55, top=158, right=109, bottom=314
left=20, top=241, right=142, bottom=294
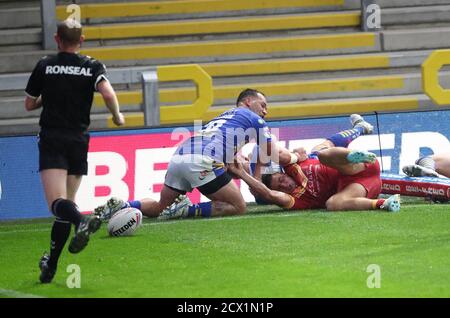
left=108, top=208, right=142, bottom=236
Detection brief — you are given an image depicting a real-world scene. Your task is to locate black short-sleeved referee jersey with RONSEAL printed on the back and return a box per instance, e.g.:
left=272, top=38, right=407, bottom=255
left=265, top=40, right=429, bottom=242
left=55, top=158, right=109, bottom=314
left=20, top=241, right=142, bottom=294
left=25, top=52, right=107, bottom=132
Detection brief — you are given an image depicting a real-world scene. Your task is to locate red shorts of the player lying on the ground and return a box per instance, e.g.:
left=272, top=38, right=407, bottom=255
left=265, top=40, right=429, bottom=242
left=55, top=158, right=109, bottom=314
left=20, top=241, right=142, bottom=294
left=337, top=161, right=381, bottom=199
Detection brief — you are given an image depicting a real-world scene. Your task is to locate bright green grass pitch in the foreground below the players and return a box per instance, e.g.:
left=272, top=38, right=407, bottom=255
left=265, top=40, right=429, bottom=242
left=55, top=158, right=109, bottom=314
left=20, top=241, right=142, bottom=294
left=0, top=202, right=450, bottom=298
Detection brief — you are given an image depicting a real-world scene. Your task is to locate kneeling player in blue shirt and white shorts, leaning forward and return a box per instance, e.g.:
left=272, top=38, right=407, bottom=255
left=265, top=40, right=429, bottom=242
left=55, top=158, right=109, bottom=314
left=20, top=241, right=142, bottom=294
left=94, top=89, right=297, bottom=220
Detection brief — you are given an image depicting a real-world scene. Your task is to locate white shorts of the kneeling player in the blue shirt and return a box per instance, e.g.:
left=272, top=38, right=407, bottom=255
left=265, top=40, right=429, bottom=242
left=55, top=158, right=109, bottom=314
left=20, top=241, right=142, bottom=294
left=164, top=154, right=231, bottom=195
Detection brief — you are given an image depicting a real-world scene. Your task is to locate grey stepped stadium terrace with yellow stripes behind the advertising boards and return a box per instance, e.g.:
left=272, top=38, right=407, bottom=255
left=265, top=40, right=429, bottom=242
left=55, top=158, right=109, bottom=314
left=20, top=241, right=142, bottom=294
left=0, top=0, right=450, bottom=134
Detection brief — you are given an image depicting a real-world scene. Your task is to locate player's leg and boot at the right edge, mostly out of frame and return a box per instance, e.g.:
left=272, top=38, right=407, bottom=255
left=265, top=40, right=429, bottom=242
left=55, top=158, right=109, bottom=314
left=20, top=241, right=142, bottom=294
left=403, top=153, right=450, bottom=178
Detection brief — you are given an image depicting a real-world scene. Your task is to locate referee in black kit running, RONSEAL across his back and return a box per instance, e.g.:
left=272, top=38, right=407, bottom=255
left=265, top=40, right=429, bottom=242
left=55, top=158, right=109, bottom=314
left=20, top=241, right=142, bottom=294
left=25, top=19, right=125, bottom=283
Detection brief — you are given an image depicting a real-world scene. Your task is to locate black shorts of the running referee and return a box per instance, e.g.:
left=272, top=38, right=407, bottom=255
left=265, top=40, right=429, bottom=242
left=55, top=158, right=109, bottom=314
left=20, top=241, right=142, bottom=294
left=38, top=130, right=89, bottom=175
